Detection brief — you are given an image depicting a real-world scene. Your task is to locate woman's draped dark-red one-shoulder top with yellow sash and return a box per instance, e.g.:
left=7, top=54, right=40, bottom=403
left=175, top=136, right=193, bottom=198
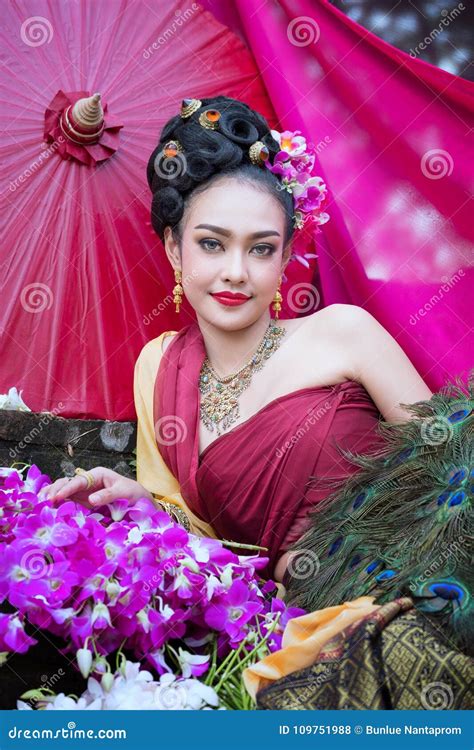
left=135, top=323, right=386, bottom=576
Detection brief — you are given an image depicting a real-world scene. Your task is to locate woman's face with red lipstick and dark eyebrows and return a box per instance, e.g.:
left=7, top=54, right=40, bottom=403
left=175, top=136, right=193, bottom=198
left=171, top=178, right=289, bottom=330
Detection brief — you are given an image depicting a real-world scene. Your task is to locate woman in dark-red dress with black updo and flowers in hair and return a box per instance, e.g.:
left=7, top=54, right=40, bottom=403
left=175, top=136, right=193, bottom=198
left=41, top=96, right=431, bottom=581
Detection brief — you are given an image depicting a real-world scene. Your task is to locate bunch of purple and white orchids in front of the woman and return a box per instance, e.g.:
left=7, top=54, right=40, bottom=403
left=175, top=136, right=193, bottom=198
left=0, top=465, right=303, bottom=708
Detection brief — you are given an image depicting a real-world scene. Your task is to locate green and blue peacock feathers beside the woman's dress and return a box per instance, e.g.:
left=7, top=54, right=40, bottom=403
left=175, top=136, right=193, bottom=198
left=284, top=370, right=474, bottom=652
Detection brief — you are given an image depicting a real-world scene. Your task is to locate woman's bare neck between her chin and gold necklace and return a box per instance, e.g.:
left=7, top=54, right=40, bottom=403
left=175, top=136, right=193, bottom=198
left=197, top=312, right=276, bottom=378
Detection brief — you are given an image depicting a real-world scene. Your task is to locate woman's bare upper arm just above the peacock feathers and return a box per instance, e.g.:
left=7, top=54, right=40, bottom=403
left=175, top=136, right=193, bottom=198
left=336, top=305, right=433, bottom=422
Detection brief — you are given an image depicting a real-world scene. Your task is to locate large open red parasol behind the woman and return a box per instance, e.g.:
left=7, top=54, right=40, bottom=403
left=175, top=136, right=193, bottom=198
left=0, top=0, right=304, bottom=420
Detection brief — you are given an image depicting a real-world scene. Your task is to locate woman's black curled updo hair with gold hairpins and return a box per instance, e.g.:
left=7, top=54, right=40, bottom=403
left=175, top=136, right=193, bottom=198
left=147, top=96, right=294, bottom=247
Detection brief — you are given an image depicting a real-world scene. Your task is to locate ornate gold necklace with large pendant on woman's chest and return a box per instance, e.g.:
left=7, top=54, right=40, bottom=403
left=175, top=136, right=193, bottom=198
left=199, top=320, right=286, bottom=435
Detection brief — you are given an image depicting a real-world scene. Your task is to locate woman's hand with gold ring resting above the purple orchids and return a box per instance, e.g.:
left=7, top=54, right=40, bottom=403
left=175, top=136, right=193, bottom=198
left=39, top=466, right=153, bottom=508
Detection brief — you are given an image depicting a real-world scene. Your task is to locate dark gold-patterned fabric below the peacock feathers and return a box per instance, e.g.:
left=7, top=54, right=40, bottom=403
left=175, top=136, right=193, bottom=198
left=257, top=597, right=474, bottom=710
